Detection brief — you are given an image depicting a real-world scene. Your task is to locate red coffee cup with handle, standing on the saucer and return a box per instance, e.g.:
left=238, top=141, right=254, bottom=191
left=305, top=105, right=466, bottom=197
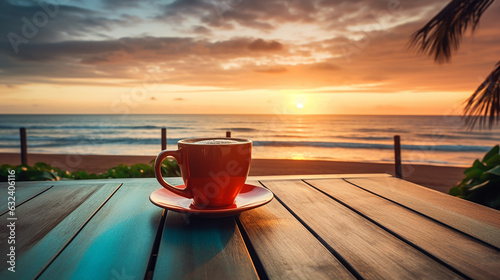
left=155, top=138, right=252, bottom=207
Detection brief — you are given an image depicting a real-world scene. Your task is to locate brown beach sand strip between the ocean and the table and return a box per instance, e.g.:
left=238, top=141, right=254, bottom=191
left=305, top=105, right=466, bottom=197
left=0, top=153, right=465, bottom=193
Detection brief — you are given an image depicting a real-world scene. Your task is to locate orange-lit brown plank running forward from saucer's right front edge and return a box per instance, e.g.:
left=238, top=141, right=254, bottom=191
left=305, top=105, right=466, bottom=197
left=239, top=181, right=355, bottom=279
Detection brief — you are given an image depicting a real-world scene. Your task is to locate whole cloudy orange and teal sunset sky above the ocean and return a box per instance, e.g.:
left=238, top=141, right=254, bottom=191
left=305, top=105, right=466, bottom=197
left=0, top=0, right=500, bottom=115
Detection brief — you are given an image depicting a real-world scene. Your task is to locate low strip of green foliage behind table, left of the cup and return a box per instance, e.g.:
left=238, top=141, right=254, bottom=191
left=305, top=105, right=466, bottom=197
left=0, top=160, right=181, bottom=182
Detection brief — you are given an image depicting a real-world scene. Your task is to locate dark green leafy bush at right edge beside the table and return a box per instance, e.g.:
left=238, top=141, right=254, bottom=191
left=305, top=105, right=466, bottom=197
left=449, top=145, right=500, bottom=210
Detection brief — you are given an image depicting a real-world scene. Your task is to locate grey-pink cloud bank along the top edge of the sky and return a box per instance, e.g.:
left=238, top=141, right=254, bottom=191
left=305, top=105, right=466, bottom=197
left=156, top=0, right=443, bottom=33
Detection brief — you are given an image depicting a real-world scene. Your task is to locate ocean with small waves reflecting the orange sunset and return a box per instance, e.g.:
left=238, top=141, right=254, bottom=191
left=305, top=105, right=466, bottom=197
left=0, top=115, right=500, bottom=166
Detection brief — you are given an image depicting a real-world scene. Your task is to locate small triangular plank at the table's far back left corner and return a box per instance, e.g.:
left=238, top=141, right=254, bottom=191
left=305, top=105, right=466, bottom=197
left=0, top=182, right=52, bottom=216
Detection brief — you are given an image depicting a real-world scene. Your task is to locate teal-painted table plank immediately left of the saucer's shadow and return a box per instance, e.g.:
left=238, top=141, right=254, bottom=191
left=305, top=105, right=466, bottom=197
left=40, top=182, right=162, bottom=279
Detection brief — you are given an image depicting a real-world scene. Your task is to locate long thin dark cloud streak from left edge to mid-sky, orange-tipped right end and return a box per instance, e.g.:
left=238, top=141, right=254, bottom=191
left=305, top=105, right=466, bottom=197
left=0, top=37, right=283, bottom=65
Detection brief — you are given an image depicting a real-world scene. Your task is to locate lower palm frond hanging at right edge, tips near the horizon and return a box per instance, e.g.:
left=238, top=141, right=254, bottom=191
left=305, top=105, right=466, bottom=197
left=464, top=61, right=500, bottom=129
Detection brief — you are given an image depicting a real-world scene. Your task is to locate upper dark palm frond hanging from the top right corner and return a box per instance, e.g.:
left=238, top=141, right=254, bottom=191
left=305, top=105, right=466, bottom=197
left=410, top=0, right=494, bottom=63
